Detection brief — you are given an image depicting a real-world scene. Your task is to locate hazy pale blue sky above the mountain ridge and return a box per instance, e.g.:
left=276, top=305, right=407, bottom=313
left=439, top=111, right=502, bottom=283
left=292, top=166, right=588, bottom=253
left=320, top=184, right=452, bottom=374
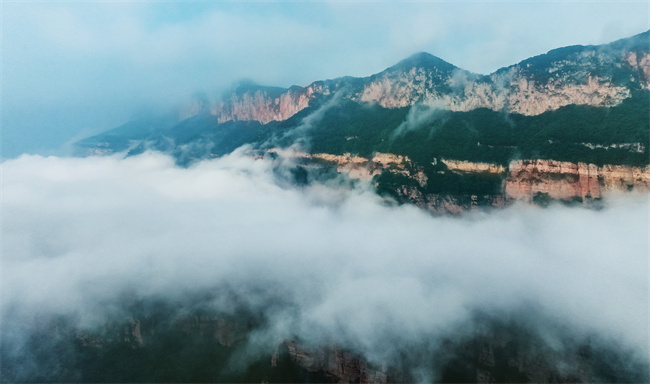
left=2, top=1, right=650, bottom=158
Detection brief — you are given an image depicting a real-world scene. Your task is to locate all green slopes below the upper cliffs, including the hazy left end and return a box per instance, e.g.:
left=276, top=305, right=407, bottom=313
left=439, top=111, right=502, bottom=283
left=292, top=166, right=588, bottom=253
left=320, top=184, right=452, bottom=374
left=80, top=90, right=650, bottom=195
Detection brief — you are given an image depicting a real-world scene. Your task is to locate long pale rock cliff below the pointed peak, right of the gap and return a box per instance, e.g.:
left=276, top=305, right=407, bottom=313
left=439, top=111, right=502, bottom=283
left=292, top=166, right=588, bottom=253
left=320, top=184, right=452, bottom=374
left=359, top=62, right=632, bottom=115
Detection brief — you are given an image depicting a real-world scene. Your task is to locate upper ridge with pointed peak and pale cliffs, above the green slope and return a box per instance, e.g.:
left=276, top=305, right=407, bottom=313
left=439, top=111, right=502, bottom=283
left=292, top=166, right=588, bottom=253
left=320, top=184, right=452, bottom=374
left=211, top=32, right=650, bottom=123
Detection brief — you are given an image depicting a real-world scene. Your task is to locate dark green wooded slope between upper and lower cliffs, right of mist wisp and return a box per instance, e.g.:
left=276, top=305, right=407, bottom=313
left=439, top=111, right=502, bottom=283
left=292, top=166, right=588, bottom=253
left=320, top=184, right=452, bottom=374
left=280, top=91, right=650, bottom=166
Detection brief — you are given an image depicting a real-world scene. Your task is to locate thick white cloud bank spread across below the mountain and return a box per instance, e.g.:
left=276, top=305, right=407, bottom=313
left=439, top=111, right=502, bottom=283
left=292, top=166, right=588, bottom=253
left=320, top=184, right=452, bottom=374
left=2, top=151, right=649, bottom=376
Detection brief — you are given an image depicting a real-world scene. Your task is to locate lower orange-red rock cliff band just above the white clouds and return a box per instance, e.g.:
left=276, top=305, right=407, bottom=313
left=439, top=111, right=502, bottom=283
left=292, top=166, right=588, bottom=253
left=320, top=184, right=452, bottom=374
left=301, top=153, right=650, bottom=214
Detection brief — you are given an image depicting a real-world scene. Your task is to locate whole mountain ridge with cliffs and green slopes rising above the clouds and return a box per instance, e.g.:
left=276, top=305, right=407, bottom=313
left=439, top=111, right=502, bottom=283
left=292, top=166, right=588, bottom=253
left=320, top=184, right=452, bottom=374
left=77, top=31, right=650, bottom=213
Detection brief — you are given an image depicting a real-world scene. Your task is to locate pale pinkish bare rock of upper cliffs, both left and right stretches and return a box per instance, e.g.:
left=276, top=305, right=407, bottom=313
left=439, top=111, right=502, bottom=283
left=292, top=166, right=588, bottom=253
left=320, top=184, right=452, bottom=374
left=211, top=70, right=628, bottom=124
